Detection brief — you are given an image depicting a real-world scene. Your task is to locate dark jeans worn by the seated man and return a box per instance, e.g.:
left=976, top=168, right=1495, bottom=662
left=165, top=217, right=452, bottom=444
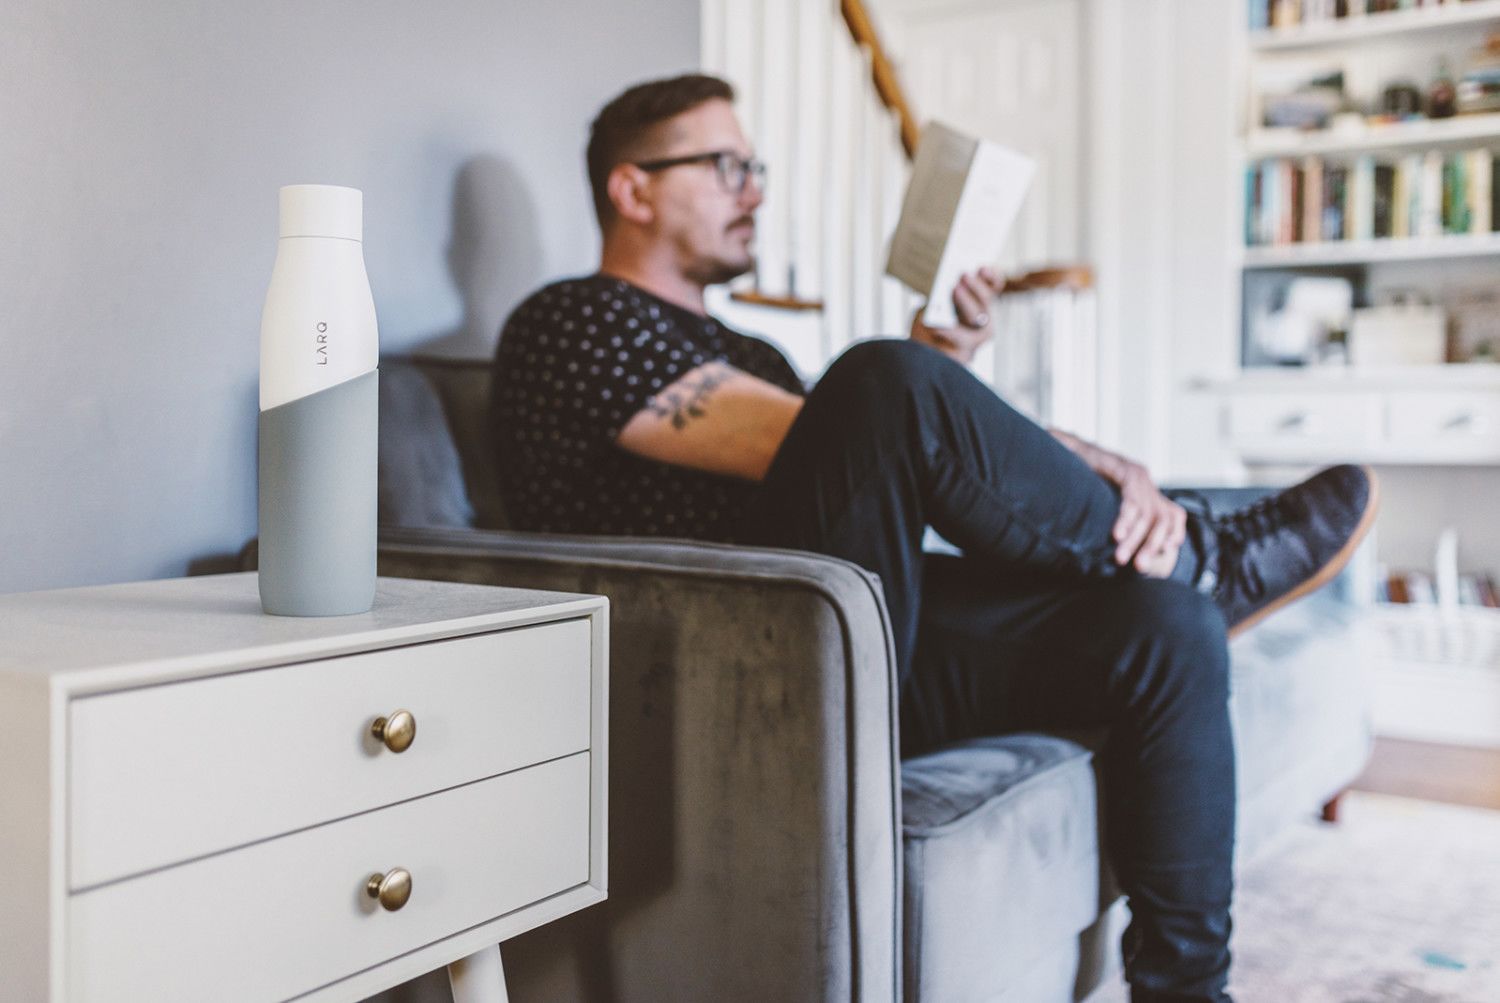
left=743, top=340, right=1235, bottom=1000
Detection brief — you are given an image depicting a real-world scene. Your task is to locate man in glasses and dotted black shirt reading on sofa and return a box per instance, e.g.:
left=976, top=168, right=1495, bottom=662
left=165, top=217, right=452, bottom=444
left=495, top=75, right=1376, bottom=1002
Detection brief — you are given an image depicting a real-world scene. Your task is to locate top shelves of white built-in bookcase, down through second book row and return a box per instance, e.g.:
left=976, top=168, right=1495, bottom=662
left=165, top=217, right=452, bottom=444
left=1241, top=0, right=1500, bottom=268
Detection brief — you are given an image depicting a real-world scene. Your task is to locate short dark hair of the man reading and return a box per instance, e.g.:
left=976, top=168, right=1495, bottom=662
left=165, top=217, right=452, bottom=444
left=588, top=73, right=735, bottom=228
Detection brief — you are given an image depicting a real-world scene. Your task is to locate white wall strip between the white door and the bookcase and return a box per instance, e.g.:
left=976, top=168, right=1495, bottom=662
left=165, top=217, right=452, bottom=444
left=1085, top=0, right=1239, bottom=481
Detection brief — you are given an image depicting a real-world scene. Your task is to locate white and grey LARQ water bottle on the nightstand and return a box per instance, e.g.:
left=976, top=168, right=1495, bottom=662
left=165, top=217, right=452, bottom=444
left=258, top=184, right=380, bottom=616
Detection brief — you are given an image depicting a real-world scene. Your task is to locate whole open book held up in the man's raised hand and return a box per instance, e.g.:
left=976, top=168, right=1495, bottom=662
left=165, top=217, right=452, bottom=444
left=885, top=121, right=1037, bottom=327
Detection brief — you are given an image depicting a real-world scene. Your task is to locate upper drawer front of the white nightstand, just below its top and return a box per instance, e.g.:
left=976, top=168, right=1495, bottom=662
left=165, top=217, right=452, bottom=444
left=68, top=619, right=591, bottom=889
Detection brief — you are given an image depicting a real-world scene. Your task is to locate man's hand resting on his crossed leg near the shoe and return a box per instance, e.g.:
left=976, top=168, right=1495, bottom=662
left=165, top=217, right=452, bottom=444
left=1053, top=429, right=1188, bottom=579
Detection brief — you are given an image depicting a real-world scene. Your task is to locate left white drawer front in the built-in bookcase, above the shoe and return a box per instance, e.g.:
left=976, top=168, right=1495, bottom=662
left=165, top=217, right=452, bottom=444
left=1230, top=393, right=1382, bottom=459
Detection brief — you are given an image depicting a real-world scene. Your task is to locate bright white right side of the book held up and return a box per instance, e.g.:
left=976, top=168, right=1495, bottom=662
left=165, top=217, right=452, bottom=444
left=923, top=141, right=1037, bottom=328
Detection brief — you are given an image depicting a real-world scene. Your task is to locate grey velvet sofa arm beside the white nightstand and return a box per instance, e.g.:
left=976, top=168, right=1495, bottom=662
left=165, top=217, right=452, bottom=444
left=378, top=529, right=902, bottom=1000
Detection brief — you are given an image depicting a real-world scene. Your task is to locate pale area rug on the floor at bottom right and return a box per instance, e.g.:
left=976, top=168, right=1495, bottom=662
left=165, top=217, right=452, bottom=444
left=1088, top=793, right=1500, bottom=1003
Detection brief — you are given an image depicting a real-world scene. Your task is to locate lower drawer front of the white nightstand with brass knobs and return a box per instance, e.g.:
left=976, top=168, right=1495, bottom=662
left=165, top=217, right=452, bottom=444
left=66, top=753, right=590, bottom=1003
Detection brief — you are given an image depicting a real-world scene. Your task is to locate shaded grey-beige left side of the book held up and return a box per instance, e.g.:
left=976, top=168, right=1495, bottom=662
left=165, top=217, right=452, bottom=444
left=885, top=121, right=980, bottom=294
